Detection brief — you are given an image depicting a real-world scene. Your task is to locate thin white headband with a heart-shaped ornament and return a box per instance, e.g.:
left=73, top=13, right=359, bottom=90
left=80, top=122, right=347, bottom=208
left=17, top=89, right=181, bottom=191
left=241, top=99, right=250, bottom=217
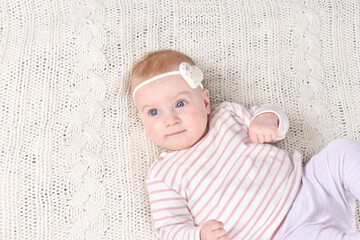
left=133, top=62, right=204, bottom=99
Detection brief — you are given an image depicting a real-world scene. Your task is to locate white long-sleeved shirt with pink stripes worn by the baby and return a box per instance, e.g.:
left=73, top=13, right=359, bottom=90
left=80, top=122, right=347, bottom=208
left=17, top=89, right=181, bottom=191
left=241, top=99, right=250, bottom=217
left=147, top=102, right=302, bottom=239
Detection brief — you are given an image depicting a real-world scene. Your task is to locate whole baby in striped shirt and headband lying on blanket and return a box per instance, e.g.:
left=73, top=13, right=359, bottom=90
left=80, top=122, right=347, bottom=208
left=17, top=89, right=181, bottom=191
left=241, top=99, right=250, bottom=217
left=131, top=50, right=360, bottom=240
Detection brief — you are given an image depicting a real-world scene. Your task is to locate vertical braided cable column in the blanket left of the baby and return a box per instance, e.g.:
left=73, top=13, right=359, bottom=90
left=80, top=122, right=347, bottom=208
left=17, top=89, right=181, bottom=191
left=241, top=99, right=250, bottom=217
left=65, top=0, right=107, bottom=239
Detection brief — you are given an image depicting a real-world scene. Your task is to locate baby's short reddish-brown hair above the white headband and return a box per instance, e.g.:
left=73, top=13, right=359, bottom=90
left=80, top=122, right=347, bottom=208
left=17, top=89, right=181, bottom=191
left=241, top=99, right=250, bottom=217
left=131, top=50, right=195, bottom=92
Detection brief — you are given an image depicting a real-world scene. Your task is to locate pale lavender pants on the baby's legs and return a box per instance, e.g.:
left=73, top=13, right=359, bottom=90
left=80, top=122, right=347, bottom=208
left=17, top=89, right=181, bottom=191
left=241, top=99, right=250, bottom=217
left=273, top=139, right=360, bottom=240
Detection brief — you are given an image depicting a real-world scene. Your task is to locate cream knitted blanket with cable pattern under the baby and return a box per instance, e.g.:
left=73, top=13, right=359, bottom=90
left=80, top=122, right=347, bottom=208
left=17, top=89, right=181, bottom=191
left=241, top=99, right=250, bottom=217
left=0, top=0, right=360, bottom=240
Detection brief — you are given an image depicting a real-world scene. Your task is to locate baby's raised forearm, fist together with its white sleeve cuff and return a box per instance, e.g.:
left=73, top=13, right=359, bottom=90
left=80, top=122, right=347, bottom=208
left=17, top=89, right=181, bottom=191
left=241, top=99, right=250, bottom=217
left=249, top=104, right=289, bottom=143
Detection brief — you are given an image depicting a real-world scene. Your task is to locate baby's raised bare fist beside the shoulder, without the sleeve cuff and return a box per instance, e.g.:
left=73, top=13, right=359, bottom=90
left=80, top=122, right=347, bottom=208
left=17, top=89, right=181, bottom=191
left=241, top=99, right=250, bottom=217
left=249, top=112, right=279, bottom=143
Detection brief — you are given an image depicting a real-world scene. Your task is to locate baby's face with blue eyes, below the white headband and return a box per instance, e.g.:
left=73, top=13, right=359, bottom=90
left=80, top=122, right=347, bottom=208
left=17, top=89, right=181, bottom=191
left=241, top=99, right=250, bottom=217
left=135, top=75, right=210, bottom=151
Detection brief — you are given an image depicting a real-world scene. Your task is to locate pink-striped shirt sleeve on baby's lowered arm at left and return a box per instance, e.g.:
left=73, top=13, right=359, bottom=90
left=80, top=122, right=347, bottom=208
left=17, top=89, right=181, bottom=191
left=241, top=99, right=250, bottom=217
left=147, top=180, right=200, bottom=240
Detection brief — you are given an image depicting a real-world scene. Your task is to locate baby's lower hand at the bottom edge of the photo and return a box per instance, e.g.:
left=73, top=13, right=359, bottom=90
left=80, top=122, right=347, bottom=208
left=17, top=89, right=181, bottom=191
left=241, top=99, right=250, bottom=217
left=200, top=220, right=228, bottom=240
